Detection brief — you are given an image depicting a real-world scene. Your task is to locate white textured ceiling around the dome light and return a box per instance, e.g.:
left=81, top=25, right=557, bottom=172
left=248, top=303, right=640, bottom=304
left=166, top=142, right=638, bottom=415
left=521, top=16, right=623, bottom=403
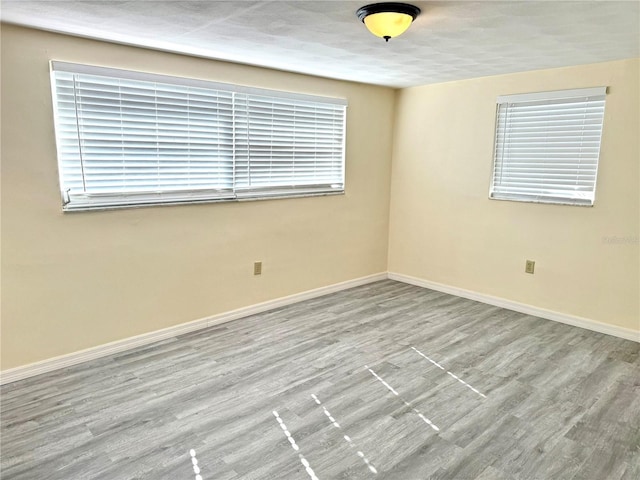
left=0, top=0, right=640, bottom=87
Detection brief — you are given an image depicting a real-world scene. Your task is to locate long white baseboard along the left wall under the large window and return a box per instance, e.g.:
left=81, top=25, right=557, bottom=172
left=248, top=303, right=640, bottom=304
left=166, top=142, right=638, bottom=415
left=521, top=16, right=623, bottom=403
left=0, top=272, right=387, bottom=385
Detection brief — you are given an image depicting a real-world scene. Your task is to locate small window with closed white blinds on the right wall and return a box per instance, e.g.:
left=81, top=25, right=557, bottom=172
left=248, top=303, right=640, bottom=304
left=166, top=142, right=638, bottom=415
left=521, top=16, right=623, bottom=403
left=489, top=87, right=606, bottom=205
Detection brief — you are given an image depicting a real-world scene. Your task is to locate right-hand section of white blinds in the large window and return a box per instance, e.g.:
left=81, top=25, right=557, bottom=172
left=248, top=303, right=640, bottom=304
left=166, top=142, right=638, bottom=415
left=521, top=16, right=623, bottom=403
left=235, top=94, right=344, bottom=195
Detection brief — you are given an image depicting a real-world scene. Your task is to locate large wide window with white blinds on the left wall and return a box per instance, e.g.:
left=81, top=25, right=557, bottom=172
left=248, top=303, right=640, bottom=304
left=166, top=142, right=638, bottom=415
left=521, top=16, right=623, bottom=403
left=51, top=62, right=346, bottom=210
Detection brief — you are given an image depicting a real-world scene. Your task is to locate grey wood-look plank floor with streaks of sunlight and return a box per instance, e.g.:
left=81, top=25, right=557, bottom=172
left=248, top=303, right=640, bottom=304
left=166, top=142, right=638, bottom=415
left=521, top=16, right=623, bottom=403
left=1, top=281, right=640, bottom=480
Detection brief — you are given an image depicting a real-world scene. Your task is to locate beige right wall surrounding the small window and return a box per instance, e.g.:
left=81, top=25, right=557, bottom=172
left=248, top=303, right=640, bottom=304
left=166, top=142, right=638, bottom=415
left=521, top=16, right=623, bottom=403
left=389, top=59, right=640, bottom=330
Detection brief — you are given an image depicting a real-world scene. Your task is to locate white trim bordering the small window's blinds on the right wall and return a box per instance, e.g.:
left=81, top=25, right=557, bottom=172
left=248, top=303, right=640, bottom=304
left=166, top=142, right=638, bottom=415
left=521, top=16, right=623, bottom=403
left=489, top=87, right=608, bottom=207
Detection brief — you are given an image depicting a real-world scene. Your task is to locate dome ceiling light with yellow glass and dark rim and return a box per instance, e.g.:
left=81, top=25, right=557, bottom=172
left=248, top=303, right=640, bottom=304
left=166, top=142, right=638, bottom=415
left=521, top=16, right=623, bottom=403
left=356, top=2, right=420, bottom=42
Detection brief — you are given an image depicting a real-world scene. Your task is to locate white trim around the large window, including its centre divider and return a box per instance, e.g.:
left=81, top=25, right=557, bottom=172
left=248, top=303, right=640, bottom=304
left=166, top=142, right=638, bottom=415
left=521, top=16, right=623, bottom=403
left=50, top=60, right=348, bottom=212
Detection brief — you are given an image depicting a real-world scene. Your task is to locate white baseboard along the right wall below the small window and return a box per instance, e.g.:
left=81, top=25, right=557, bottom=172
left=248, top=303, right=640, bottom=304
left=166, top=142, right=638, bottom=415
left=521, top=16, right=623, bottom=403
left=388, top=272, right=640, bottom=342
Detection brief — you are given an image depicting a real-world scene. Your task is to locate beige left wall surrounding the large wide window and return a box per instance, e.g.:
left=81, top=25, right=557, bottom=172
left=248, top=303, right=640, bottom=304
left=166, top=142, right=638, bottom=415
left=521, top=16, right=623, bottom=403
left=1, top=25, right=394, bottom=369
